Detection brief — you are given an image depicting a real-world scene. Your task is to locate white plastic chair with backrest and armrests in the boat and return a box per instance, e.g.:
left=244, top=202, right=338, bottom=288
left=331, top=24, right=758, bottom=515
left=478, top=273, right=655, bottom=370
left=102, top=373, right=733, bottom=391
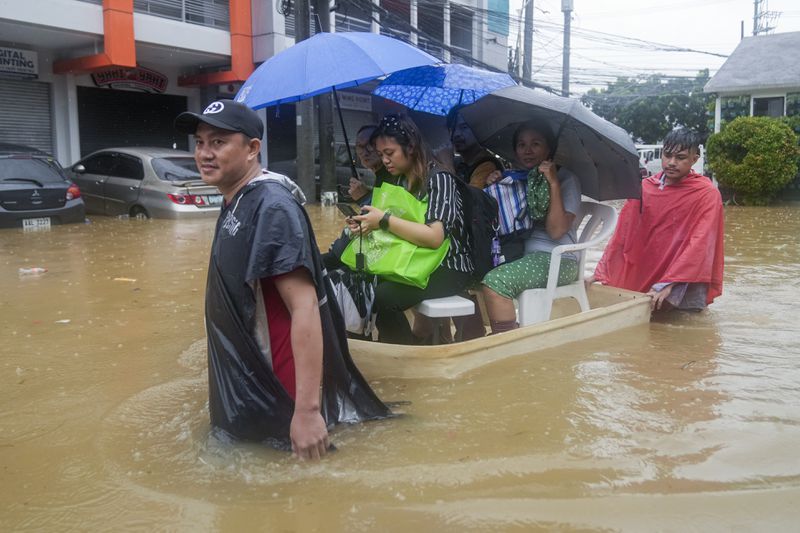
left=517, top=202, right=617, bottom=326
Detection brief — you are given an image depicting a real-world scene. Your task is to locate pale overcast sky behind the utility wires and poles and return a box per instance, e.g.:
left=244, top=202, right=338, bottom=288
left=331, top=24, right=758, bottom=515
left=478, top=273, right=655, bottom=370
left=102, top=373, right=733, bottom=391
left=509, top=0, right=800, bottom=94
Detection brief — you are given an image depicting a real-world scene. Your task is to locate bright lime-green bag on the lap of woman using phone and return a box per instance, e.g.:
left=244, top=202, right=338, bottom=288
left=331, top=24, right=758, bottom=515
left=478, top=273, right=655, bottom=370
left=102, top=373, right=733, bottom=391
left=341, top=182, right=450, bottom=289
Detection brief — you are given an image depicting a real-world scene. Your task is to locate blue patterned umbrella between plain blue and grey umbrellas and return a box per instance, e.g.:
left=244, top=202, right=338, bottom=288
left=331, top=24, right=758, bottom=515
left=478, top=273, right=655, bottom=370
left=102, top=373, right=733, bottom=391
left=372, top=64, right=516, bottom=115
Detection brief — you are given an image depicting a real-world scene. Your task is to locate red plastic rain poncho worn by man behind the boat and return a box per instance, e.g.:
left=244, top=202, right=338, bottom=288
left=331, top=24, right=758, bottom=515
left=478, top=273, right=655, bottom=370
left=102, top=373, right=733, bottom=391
left=594, top=172, right=724, bottom=304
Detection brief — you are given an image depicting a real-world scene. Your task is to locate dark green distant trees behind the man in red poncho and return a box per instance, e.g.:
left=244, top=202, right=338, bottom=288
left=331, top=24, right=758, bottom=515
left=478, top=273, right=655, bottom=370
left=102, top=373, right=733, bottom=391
left=581, top=69, right=713, bottom=143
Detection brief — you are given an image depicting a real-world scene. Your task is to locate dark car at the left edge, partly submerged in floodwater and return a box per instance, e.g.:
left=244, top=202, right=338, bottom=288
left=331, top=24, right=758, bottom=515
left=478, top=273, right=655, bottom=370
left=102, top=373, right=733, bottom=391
left=0, top=144, right=86, bottom=229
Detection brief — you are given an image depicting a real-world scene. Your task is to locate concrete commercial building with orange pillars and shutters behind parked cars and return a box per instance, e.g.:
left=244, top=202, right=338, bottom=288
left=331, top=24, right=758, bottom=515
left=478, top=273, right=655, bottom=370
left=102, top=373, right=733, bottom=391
left=0, top=0, right=508, bottom=165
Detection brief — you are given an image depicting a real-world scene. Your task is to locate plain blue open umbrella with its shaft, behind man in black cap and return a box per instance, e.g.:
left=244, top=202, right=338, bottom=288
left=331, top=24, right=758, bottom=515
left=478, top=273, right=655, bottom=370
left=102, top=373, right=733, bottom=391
left=236, top=32, right=439, bottom=179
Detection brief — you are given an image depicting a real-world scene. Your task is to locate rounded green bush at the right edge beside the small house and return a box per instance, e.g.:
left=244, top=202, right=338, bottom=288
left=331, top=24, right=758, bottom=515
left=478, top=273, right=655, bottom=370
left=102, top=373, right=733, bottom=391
left=706, top=117, right=800, bottom=205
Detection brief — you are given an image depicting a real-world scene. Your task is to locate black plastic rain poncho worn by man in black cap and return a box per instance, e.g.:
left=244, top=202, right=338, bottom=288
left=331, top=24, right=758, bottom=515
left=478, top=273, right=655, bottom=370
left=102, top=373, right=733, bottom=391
left=206, top=179, right=391, bottom=447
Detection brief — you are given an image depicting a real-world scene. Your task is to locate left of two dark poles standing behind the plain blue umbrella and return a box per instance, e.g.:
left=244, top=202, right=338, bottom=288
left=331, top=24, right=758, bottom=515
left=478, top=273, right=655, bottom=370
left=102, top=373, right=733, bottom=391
left=294, top=0, right=316, bottom=201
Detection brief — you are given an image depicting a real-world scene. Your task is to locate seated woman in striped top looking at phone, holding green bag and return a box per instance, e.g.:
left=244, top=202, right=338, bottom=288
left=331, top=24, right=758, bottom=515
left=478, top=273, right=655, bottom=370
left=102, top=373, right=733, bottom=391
left=342, top=114, right=473, bottom=344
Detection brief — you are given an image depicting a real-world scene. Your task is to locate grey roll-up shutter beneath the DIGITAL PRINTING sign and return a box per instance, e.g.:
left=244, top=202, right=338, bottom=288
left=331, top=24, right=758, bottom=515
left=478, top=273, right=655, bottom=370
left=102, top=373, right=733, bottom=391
left=0, top=79, right=53, bottom=154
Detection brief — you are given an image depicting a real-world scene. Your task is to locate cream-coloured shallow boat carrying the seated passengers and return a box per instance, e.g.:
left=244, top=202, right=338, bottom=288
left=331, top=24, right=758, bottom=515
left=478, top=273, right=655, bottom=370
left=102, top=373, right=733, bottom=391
left=348, top=284, right=650, bottom=379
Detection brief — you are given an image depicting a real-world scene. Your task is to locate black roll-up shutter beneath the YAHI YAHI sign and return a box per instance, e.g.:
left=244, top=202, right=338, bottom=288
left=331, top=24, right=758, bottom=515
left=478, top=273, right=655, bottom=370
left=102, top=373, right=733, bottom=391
left=78, top=87, right=189, bottom=157
